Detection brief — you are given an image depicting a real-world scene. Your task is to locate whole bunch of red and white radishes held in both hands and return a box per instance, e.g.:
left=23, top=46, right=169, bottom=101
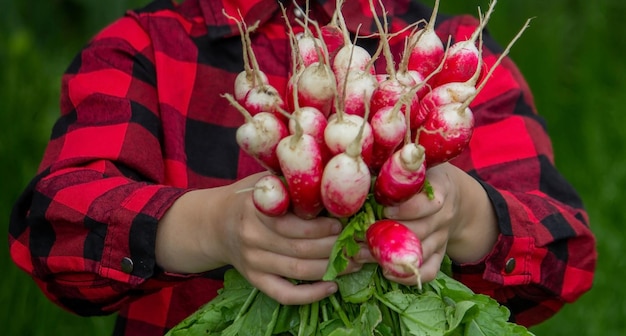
left=224, top=0, right=528, bottom=284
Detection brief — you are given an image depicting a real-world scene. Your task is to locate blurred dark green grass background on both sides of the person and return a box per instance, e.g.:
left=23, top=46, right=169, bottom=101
left=0, top=0, right=626, bottom=336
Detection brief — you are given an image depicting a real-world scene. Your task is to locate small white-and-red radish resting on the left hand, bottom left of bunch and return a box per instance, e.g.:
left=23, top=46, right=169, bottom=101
left=252, top=175, right=290, bottom=217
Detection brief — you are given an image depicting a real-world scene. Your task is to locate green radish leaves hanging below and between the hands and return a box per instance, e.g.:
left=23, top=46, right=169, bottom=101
left=167, top=199, right=532, bottom=336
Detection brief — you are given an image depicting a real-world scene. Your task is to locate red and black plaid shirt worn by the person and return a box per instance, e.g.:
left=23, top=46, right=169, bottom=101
left=9, top=0, right=596, bottom=336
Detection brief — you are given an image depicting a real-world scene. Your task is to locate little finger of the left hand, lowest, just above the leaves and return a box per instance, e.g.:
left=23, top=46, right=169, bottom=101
left=253, top=274, right=337, bottom=305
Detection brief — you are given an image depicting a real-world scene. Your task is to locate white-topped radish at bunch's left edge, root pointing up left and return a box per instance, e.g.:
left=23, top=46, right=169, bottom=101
left=223, top=94, right=288, bottom=173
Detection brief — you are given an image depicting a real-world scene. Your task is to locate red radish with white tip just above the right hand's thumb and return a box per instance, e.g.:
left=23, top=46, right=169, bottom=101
left=374, top=143, right=426, bottom=206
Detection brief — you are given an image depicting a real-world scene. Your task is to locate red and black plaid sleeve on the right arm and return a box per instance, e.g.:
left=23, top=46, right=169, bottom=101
left=438, top=17, right=596, bottom=326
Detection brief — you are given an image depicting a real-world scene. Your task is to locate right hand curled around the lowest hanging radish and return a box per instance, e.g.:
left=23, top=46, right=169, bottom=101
left=356, top=163, right=498, bottom=285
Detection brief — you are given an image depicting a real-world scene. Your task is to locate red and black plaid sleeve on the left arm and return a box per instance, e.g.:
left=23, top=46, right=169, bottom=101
left=10, top=17, right=190, bottom=315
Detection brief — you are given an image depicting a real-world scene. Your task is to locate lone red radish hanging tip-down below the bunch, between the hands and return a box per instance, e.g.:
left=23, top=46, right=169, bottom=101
left=365, top=219, right=423, bottom=290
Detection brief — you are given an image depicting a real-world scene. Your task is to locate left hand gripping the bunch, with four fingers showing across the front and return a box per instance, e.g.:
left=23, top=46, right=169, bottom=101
left=157, top=174, right=359, bottom=305
